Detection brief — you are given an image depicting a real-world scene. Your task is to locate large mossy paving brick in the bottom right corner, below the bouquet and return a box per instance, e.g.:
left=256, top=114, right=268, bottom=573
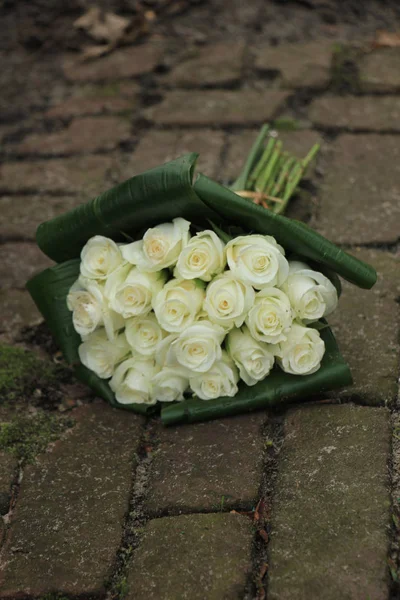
left=268, top=405, right=390, bottom=600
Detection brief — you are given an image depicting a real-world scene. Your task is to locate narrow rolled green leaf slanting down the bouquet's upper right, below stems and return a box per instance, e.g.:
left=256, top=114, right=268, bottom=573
left=194, top=175, right=377, bottom=289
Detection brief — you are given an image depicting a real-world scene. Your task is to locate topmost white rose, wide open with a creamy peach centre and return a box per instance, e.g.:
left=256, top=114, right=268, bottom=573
left=121, top=217, right=190, bottom=272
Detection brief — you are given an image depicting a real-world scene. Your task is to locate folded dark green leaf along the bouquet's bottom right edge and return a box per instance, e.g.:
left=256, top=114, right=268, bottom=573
left=161, top=327, right=352, bottom=425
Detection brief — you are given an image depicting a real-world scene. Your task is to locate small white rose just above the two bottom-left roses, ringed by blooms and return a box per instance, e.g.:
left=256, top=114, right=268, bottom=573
left=125, top=313, right=163, bottom=357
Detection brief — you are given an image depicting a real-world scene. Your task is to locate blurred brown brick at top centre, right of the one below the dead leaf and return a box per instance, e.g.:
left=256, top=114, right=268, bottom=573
left=166, top=41, right=245, bottom=87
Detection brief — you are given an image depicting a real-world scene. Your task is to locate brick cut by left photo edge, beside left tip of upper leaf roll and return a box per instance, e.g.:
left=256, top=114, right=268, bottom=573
left=0, top=242, right=54, bottom=289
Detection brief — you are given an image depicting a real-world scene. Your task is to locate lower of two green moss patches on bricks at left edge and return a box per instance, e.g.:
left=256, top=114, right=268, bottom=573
left=0, top=412, right=73, bottom=462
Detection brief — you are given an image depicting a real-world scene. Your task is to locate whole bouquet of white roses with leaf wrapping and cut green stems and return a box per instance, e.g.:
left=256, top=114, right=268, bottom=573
left=28, top=128, right=376, bottom=424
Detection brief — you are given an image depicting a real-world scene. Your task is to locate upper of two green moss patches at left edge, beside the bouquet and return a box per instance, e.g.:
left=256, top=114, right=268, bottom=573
left=0, top=345, right=60, bottom=401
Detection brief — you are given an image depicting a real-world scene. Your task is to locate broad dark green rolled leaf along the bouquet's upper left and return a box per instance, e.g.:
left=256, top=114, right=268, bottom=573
left=36, top=153, right=216, bottom=262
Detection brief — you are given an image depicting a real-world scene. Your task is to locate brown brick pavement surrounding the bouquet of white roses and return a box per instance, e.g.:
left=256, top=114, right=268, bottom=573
left=0, top=3, right=400, bottom=600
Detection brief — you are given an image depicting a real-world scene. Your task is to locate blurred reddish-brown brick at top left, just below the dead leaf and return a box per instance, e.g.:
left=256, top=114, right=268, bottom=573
left=63, top=44, right=163, bottom=83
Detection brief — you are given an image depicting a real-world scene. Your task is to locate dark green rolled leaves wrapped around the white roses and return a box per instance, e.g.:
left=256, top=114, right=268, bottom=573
left=27, top=153, right=376, bottom=425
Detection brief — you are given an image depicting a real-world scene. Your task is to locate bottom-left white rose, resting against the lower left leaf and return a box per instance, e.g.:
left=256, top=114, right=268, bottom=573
left=110, top=357, right=159, bottom=404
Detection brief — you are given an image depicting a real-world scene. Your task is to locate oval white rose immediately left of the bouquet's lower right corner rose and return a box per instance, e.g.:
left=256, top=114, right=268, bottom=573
left=226, top=327, right=275, bottom=385
